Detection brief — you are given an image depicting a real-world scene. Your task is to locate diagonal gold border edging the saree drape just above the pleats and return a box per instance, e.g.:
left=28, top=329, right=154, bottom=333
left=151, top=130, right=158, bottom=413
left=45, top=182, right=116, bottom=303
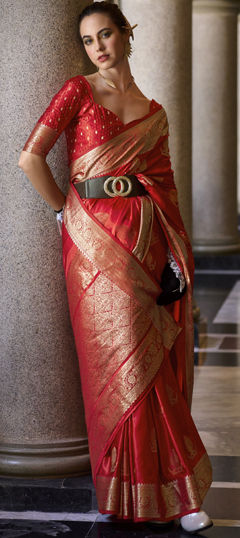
left=88, top=327, right=164, bottom=473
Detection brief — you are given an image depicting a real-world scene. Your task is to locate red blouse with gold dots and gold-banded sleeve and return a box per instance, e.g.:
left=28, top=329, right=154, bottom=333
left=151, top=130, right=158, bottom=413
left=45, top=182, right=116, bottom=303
left=23, top=75, right=161, bottom=165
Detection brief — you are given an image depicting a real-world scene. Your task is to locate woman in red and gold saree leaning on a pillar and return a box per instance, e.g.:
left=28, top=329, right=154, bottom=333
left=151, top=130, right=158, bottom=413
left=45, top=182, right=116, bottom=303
left=19, top=2, right=211, bottom=532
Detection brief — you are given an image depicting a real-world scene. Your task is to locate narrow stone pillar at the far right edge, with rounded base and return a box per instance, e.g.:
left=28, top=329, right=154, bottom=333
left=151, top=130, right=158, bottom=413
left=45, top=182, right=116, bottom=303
left=193, top=0, right=240, bottom=253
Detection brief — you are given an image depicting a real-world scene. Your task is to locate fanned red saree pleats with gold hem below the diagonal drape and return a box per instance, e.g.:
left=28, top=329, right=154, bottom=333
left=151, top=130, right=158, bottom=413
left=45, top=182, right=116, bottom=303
left=96, top=357, right=211, bottom=521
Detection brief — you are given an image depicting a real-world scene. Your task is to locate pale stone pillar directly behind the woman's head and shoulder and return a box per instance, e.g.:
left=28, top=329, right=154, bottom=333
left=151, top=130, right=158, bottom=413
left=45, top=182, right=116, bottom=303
left=120, top=0, right=192, bottom=235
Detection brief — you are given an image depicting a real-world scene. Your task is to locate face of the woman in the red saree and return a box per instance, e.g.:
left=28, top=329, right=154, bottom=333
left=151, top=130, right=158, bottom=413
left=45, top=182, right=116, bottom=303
left=80, top=13, right=128, bottom=69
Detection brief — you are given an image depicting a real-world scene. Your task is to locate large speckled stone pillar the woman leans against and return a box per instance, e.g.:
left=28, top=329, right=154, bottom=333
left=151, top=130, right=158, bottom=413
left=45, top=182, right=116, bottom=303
left=0, top=0, right=94, bottom=477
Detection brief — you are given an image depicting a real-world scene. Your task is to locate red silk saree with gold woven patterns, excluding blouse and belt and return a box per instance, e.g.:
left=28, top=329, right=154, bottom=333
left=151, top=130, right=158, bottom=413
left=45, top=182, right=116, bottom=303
left=63, top=104, right=211, bottom=521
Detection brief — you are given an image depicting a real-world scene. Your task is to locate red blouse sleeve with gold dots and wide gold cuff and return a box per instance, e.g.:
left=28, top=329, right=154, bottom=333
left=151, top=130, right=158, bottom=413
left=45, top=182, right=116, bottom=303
left=23, top=79, right=82, bottom=158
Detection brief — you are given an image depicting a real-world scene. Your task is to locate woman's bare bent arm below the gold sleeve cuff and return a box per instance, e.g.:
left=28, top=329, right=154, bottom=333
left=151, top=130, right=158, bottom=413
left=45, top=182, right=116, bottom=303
left=18, top=151, right=65, bottom=211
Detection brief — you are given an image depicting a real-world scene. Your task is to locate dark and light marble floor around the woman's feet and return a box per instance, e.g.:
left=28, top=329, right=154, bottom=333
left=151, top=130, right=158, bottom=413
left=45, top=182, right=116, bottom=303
left=0, top=269, right=240, bottom=538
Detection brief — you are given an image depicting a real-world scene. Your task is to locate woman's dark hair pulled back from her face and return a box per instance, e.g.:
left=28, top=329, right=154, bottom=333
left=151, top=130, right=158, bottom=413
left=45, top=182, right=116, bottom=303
left=78, top=2, right=128, bottom=41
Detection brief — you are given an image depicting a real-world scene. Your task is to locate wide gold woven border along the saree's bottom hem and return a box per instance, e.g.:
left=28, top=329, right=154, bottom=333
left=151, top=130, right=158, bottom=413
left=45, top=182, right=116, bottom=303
left=96, top=454, right=212, bottom=520
